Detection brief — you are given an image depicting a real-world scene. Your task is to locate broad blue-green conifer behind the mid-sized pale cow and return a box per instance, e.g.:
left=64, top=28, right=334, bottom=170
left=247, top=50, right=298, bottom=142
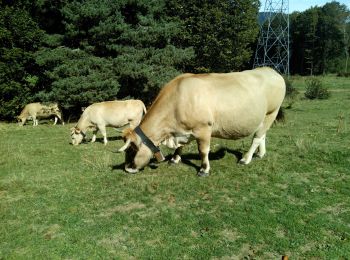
left=36, top=0, right=193, bottom=114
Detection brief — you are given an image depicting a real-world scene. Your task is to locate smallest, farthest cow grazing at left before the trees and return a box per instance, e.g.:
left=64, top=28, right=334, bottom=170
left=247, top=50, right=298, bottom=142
left=17, top=102, right=64, bottom=126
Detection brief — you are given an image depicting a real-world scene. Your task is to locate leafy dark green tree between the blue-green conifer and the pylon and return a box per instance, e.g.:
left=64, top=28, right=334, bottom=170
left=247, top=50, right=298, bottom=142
left=166, top=0, right=259, bottom=72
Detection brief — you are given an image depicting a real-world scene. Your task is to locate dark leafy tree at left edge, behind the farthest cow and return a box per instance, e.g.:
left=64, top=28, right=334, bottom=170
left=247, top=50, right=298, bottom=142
left=0, top=5, right=44, bottom=120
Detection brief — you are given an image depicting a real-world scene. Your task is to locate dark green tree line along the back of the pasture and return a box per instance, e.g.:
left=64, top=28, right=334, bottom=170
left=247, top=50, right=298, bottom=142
left=0, top=0, right=350, bottom=120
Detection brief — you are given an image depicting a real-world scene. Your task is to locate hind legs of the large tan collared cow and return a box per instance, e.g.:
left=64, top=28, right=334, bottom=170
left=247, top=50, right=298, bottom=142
left=239, top=109, right=279, bottom=164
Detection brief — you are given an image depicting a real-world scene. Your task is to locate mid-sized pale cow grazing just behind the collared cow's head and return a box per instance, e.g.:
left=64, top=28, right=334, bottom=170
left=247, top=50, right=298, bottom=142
left=71, top=100, right=146, bottom=145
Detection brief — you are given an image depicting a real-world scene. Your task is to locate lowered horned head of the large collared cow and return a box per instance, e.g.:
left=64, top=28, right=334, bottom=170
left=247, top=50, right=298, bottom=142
left=118, top=128, right=153, bottom=173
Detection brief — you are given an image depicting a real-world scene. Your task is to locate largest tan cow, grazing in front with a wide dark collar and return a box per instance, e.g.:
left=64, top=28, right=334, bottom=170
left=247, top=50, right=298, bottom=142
left=119, top=68, right=285, bottom=176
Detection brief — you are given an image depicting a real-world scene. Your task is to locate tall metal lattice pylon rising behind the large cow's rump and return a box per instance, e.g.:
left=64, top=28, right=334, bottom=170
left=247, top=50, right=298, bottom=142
left=254, top=0, right=289, bottom=75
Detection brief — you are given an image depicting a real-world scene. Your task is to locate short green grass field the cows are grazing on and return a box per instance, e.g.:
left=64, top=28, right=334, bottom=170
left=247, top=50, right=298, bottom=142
left=0, top=77, right=350, bottom=259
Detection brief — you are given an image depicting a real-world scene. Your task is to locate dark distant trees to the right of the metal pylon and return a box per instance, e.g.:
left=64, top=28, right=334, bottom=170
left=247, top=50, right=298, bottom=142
left=290, top=1, right=349, bottom=75
